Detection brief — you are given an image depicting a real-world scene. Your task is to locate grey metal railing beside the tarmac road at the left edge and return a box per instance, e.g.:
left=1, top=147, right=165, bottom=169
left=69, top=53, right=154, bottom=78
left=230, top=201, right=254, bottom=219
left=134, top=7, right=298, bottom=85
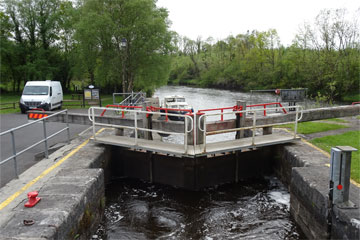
left=0, top=109, right=70, bottom=178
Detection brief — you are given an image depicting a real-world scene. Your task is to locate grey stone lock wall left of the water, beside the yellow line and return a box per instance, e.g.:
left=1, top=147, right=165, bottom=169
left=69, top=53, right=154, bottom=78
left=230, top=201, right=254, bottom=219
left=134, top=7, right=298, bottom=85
left=0, top=140, right=110, bottom=239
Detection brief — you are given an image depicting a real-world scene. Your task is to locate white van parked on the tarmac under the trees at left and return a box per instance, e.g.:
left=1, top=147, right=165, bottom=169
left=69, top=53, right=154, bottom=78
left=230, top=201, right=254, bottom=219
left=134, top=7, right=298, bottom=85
left=19, top=80, right=63, bottom=113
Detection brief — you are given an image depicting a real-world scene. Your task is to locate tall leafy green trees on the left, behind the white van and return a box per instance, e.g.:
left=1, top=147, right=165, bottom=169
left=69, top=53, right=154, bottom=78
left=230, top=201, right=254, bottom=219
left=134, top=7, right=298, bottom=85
left=0, top=0, right=173, bottom=95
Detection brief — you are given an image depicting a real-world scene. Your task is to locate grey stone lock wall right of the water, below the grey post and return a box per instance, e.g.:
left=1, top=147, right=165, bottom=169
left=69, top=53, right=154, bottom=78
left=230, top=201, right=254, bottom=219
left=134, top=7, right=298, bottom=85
left=274, top=141, right=360, bottom=239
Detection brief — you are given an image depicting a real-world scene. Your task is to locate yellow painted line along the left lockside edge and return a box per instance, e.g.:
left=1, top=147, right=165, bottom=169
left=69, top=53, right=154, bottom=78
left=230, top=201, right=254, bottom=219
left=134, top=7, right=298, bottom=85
left=0, top=128, right=105, bottom=211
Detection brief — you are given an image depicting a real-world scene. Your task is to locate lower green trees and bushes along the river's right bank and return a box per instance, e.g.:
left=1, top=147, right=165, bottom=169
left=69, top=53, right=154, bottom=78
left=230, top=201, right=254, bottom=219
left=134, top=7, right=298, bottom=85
left=170, top=9, right=360, bottom=101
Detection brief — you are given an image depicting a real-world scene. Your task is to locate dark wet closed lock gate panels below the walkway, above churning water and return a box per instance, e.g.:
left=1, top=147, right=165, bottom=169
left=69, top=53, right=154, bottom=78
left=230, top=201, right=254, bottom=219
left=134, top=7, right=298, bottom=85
left=111, top=147, right=272, bottom=190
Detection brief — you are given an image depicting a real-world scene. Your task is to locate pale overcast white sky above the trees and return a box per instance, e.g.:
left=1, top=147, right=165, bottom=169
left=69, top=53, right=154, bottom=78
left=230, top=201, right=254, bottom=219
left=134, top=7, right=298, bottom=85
left=157, top=0, right=360, bottom=46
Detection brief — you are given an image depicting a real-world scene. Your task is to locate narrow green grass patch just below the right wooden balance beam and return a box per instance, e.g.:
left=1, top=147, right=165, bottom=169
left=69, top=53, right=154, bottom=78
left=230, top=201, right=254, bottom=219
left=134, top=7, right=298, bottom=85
left=279, top=122, right=346, bottom=134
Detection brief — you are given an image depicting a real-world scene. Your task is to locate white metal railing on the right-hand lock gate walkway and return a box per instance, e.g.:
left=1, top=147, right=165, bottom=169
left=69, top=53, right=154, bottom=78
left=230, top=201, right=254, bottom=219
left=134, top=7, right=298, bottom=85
left=197, top=106, right=303, bottom=153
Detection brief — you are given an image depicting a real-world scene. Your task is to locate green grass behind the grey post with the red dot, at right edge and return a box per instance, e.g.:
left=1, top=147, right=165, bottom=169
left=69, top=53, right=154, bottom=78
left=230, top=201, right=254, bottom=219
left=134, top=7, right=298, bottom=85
left=310, top=131, right=360, bottom=183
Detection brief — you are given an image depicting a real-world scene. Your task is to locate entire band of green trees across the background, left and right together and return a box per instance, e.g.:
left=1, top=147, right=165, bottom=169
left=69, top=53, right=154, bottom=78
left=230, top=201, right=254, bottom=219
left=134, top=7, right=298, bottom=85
left=0, top=0, right=360, bottom=101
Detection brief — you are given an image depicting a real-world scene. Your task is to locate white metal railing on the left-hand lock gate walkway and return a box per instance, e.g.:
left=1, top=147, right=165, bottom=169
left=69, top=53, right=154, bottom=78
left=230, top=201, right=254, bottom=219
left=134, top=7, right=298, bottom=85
left=88, top=107, right=195, bottom=153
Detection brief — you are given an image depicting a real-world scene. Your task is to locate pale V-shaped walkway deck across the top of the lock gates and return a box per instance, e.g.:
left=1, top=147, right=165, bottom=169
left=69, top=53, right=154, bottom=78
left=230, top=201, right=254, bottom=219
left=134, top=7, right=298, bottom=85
left=95, top=132, right=300, bottom=157
